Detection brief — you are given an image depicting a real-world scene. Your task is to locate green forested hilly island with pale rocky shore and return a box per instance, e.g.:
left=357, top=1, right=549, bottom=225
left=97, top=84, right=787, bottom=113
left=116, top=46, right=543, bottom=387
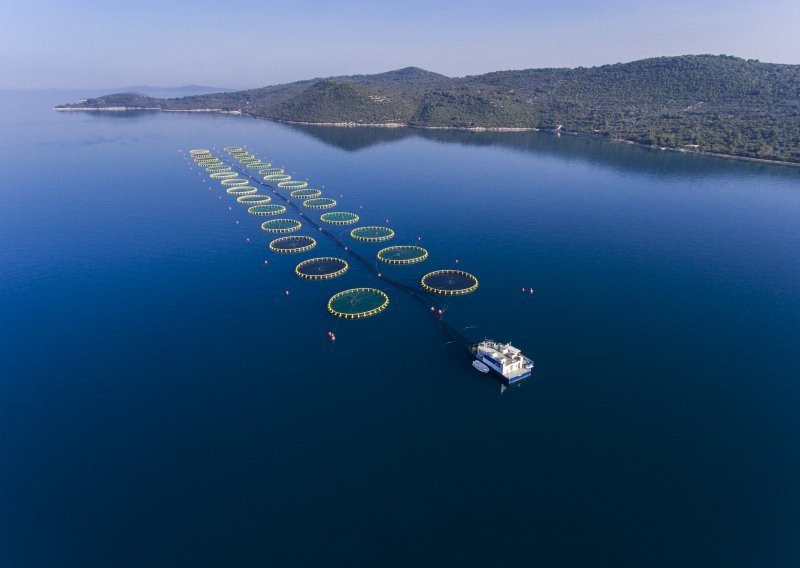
left=56, top=55, right=800, bottom=163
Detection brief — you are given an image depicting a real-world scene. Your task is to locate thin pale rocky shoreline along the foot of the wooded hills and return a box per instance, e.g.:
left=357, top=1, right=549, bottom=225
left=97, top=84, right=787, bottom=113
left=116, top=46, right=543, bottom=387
left=53, top=106, right=800, bottom=168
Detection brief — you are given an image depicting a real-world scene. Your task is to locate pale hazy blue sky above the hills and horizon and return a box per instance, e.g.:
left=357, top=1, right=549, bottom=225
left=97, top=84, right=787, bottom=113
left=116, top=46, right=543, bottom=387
left=0, top=0, right=800, bottom=88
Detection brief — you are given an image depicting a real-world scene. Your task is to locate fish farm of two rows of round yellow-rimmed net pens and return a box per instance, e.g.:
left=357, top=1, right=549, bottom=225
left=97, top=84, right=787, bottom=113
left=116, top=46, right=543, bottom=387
left=184, top=146, right=510, bottom=378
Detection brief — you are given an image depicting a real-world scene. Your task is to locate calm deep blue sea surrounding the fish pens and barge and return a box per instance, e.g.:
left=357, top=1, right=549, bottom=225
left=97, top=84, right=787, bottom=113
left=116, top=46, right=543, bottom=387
left=0, top=92, right=800, bottom=567
